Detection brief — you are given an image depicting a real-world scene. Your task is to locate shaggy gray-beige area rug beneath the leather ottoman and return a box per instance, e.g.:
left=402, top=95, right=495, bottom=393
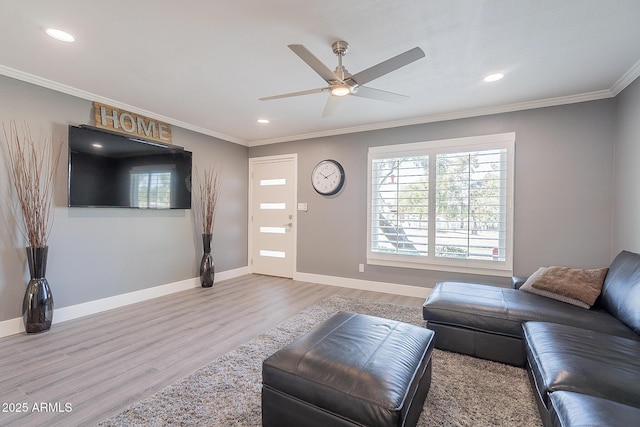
left=100, top=297, right=542, bottom=427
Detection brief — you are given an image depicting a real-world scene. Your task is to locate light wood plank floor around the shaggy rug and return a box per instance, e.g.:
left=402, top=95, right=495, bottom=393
left=0, top=275, right=424, bottom=427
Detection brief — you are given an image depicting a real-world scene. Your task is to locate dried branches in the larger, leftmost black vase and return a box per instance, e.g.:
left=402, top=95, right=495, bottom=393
left=2, top=121, right=62, bottom=248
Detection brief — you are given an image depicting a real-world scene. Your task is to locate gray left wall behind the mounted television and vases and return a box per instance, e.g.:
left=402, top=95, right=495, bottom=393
left=0, top=76, right=248, bottom=321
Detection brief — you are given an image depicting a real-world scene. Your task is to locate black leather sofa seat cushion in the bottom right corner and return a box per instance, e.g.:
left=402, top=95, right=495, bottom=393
left=550, top=391, right=640, bottom=427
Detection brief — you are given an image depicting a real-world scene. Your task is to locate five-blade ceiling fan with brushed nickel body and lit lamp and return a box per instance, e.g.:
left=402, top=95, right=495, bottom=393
left=259, top=40, right=425, bottom=117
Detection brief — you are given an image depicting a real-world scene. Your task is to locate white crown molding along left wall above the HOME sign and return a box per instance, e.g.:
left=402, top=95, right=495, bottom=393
left=0, top=65, right=247, bottom=147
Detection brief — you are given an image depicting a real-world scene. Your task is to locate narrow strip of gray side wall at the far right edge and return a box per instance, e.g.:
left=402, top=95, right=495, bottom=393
left=613, top=79, right=640, bottom=253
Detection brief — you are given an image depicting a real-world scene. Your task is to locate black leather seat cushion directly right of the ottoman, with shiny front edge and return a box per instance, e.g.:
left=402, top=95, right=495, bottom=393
left=523, top=322, right=640, bottom=409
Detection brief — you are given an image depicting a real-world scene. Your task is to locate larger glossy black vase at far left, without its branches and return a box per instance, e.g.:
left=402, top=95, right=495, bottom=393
left=22, top=246, right=53, bottom=334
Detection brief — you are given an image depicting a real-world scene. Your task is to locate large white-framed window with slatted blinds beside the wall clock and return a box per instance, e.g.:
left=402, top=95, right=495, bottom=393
left=367, top=133, right=515, bottom=276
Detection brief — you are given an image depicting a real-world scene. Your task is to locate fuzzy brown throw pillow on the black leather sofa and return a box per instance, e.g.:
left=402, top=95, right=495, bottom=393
left=531, top=267, right=608, bottom=306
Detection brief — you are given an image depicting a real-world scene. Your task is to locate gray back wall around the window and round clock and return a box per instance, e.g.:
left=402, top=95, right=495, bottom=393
left=249, top=99, right=615, bottom=287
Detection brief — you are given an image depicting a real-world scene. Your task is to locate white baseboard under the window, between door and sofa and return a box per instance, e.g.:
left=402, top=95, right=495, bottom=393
left=293, top=272, right=431, bottom=298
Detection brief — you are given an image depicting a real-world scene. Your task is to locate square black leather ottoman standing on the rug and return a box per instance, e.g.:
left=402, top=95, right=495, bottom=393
left=262, top=312, right=434, bottom=427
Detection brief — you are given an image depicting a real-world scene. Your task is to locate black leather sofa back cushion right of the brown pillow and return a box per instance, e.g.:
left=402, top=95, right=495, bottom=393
left=601, top=251, right=640, bottom=334
